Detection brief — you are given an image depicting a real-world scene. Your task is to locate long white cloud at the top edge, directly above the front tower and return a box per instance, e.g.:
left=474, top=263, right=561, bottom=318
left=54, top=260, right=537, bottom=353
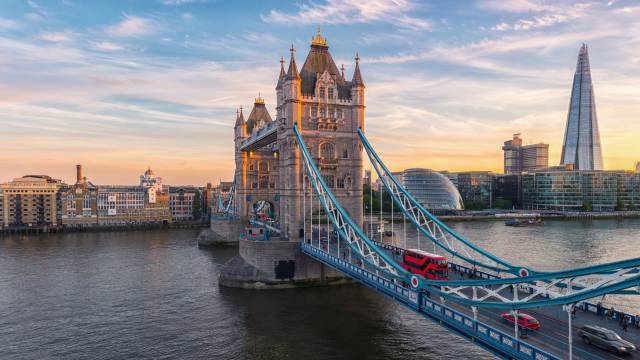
left=260, top=0, right=432, bottom=30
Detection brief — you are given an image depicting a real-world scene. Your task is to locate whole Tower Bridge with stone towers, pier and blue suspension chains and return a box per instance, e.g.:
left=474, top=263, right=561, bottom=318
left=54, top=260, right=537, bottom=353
left=220, top=32, right=640, bottom=359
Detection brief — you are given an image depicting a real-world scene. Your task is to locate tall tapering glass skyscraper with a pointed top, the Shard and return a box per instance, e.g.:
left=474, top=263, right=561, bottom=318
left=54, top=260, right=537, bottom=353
left=560, top=44, right=603, bottom=170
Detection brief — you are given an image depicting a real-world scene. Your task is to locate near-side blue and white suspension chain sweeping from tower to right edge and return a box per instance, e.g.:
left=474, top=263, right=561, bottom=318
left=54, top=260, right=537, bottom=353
left=294, top=126, right=640, bottom=309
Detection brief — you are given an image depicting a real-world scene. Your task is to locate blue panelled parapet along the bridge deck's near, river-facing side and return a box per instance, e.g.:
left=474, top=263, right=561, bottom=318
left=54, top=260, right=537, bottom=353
left=301, top=243, right=560, bottom=360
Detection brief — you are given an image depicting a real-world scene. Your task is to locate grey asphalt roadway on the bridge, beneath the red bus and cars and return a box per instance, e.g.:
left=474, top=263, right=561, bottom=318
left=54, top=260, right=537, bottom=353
left=314, top=230, right=640, bottom=360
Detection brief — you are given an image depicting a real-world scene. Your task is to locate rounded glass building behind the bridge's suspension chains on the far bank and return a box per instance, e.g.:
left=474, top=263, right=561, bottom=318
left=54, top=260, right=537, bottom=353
left=395, top=168, right=464, bottom=210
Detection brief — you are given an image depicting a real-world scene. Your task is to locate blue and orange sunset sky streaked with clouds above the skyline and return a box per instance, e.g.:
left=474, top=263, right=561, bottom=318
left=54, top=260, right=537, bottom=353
left=0, top=0, right=640, bottom=185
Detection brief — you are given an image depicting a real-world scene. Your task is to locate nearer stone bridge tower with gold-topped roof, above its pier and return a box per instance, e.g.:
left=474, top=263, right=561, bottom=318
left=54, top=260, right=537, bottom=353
left=276, top=31, right=364, bottom=241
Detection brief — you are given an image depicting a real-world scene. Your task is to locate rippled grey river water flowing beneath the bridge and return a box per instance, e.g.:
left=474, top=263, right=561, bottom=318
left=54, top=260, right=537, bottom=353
left=0, top=220, right=640, bottom=359
